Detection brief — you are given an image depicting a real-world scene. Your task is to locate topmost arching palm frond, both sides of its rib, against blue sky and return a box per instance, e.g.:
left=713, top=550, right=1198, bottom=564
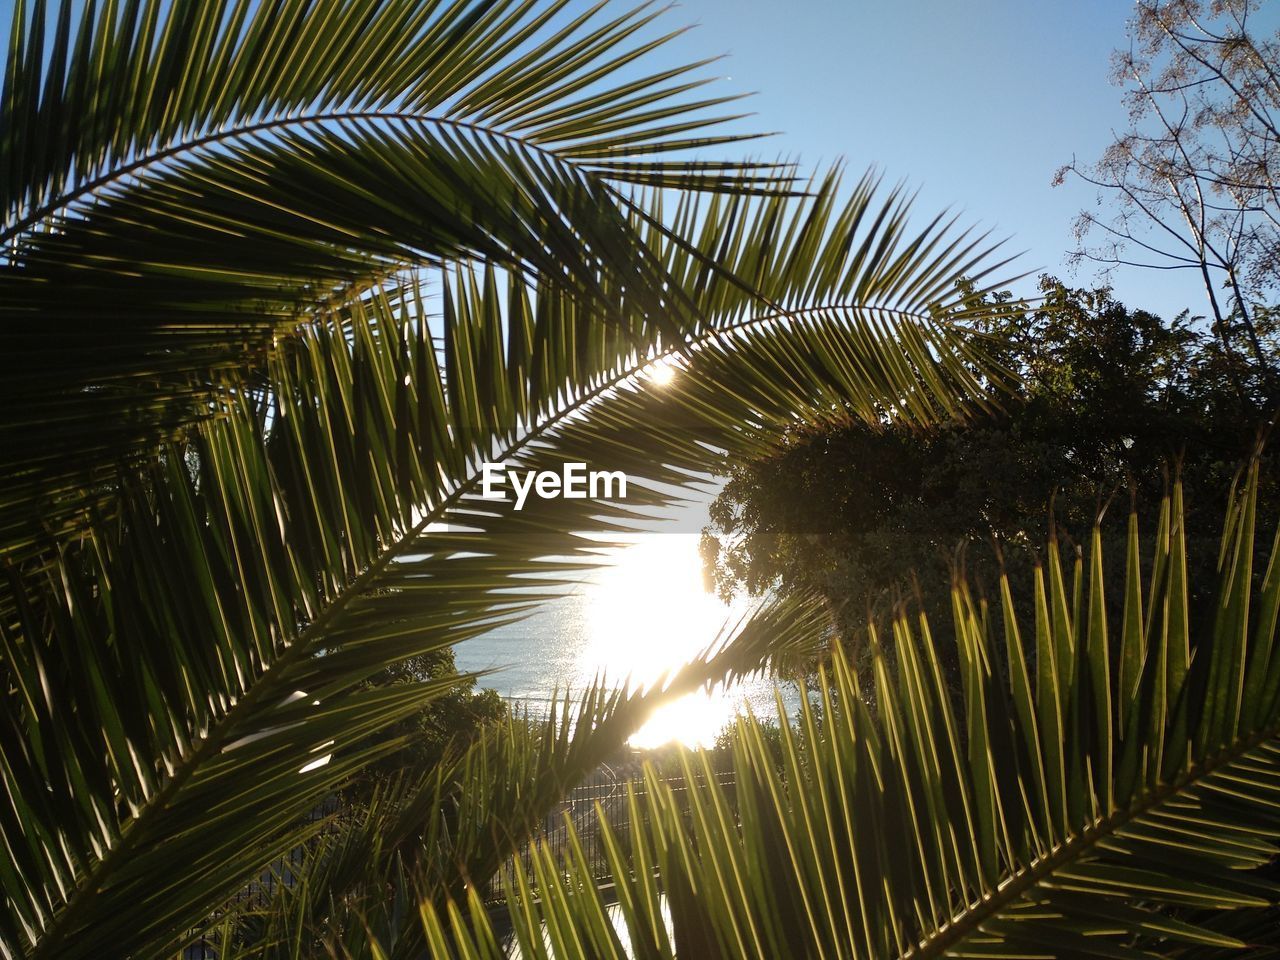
left=0, top=0, right=788, bottom=562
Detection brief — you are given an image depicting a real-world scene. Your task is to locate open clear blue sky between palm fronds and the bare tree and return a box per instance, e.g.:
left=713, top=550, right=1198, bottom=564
left=659, top=0, right=1204, bottom=317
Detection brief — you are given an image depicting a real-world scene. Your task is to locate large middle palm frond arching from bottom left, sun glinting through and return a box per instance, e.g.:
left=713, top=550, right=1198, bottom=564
left=0, top=175, right=1018, bottom=957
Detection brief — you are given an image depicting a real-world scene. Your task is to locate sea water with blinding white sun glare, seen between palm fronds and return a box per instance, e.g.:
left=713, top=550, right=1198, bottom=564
left=457, top=532, right=797, bottom=748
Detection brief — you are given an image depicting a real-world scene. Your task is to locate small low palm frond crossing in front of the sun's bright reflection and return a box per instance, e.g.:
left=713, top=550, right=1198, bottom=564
left=230, top=596, right=829, bottom=957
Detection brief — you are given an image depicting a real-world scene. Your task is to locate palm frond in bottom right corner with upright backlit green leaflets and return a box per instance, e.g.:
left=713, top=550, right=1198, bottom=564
left=422, top=463, right=1280, bottom=959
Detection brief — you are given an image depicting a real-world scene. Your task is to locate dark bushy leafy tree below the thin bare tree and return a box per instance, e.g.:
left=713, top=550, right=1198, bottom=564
left=703, top=276, right=1277, bottom=647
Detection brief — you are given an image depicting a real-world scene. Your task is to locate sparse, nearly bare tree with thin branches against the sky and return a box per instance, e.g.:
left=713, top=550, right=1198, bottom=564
left=1055, top=0, right=1280, bottom=399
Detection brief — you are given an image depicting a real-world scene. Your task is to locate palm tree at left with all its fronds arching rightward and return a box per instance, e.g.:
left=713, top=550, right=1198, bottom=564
left=0, top=0, right=1018, bottom=957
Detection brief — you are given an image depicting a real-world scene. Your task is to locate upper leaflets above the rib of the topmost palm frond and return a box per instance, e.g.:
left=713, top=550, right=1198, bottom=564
left=0, top=0, right=768, bottom=243
